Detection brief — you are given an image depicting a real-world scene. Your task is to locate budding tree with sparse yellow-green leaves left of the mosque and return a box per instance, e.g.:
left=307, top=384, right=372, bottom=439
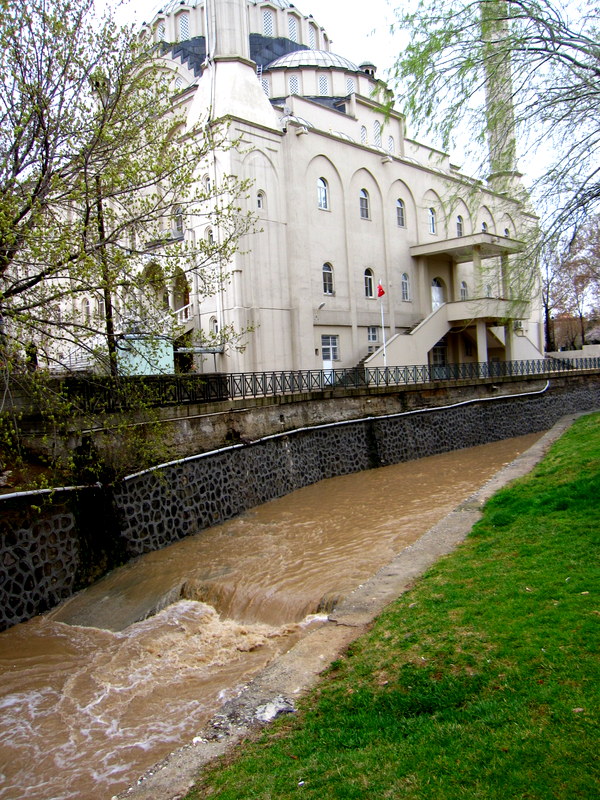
left=0, top=0, right=253, bottom=382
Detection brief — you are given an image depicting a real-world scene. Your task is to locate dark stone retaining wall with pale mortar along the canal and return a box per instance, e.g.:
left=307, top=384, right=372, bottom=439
left=0, top=375, right=600, bottom=629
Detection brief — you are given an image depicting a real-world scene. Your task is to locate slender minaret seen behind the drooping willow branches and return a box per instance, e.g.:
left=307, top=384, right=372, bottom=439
left=479, top=0, right=521, bottom=192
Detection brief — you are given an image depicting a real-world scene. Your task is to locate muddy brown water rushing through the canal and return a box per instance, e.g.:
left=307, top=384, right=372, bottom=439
left=0, top=435, right=539, bottom=800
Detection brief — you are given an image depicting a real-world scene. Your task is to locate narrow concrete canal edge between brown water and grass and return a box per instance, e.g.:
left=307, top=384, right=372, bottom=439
left=111, top=415, right=577, bottom=800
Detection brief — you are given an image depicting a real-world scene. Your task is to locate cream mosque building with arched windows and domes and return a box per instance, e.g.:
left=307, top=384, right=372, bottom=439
left=144, top=0, right=543, bottom=372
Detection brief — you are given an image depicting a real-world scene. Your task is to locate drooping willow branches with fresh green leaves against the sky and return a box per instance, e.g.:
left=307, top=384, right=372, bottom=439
left=395, top=0, right=600, bottom=231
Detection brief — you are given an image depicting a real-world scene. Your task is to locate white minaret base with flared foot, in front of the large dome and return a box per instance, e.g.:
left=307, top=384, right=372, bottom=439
left=188, top=0, right=280, bottom=130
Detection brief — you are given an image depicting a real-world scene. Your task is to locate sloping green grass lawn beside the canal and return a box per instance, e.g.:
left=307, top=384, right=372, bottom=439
left=188, top=415, right=600, bottom=800
